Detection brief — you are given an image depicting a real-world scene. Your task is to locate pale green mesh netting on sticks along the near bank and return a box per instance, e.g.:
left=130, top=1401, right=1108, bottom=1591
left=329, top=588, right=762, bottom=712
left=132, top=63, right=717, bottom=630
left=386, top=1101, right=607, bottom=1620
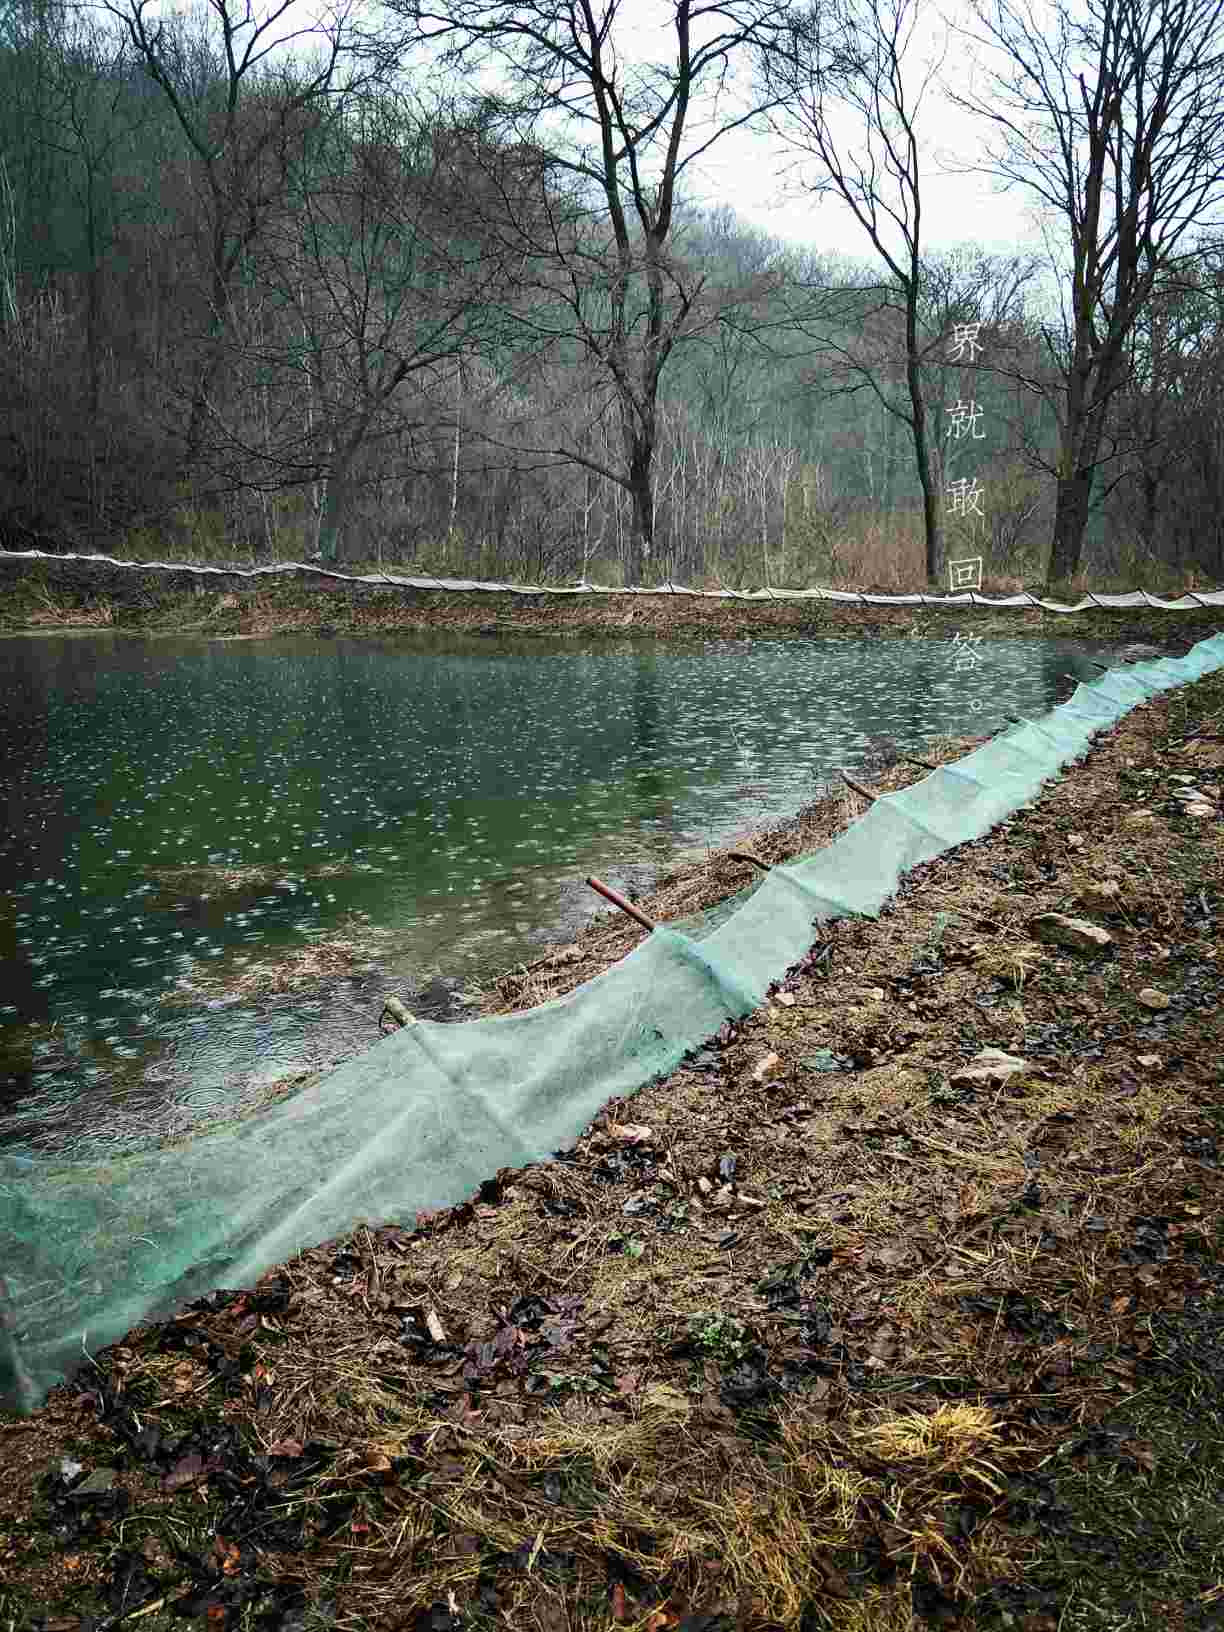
left=0, top=635, right=1224, bottom=1412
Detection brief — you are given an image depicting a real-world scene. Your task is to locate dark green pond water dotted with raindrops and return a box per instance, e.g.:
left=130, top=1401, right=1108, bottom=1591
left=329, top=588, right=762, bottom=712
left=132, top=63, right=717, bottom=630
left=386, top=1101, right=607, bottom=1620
left=0, top=635, right=1122, bottom=1152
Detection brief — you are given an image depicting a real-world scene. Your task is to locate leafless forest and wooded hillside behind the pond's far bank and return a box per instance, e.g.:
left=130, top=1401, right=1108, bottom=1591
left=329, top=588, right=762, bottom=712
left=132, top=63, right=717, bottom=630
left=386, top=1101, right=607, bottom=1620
left=0, top=0, right=1224, bottom=589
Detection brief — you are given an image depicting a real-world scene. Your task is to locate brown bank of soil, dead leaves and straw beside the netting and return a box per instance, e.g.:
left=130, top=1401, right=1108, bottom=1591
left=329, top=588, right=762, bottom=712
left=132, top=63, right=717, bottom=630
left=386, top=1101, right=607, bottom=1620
left=0, top=623, right=1224, bottom=1632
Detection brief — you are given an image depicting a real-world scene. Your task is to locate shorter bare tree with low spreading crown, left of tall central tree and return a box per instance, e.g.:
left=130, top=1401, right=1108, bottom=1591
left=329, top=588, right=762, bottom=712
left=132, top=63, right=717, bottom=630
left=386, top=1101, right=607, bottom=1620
left=225, top=93, right=522, bottom=560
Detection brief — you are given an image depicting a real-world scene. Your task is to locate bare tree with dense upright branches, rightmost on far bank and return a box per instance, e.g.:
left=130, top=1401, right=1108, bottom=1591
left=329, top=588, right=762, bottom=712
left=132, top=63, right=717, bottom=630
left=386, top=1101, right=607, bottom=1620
left=955, top=0, right=1224, bottom=583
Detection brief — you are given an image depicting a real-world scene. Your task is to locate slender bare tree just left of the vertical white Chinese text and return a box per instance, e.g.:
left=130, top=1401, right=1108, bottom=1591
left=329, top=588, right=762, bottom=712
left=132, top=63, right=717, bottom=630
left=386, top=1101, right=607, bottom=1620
left=759, top=0, right=940, bottom=581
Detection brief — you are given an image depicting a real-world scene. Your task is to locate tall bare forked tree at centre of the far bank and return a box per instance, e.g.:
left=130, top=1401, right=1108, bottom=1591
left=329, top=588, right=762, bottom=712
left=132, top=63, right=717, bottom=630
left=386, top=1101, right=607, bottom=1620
left=388, top=0, right=796, bottom=578
